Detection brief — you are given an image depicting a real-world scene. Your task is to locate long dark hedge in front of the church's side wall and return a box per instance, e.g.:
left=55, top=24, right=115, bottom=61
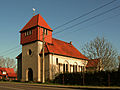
left=52, top=71, right=120, bottom=86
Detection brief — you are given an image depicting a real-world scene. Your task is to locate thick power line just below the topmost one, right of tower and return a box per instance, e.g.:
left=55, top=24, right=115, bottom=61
left=53, top=5, right=120, bottom=35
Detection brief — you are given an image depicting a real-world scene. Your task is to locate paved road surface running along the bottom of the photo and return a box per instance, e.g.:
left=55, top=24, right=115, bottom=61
left=0, top=82, right=120, bottom=90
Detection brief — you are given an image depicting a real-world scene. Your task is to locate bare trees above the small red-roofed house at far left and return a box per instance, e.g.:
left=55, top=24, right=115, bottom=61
left=0, top=56, right=17, bottom=71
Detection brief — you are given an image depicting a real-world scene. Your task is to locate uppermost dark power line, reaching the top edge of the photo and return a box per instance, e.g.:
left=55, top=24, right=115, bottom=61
left=53, top=0, right=117, bottom=30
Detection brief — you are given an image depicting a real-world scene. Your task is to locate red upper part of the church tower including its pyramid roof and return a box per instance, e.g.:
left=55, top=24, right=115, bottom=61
left=20, top=14, right=53, bottom=45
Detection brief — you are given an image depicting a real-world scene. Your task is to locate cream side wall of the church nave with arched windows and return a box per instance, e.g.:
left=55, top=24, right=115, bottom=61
left=49, top=54, right=88, bottom=79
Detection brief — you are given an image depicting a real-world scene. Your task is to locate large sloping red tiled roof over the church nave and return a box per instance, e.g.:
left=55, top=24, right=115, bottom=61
left=40, top=38, right=88, bottom=59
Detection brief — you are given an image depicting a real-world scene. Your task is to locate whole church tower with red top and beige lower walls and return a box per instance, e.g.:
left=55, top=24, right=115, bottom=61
left=20, top=14, right=53, bottom=82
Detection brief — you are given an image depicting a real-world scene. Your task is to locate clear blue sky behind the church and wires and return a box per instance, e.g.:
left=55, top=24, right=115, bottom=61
left=0, top=0, right=120, bottom=59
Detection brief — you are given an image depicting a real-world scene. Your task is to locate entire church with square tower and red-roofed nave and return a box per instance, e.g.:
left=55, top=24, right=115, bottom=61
left=17, top=14, right=88, bottom=83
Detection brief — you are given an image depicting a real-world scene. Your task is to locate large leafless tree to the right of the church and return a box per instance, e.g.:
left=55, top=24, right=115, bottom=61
left=82, top=37, right=118, bottom=70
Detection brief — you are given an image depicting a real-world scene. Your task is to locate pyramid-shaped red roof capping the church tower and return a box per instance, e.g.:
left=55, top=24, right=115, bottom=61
left=20, top=14, right=52, bottom=32
